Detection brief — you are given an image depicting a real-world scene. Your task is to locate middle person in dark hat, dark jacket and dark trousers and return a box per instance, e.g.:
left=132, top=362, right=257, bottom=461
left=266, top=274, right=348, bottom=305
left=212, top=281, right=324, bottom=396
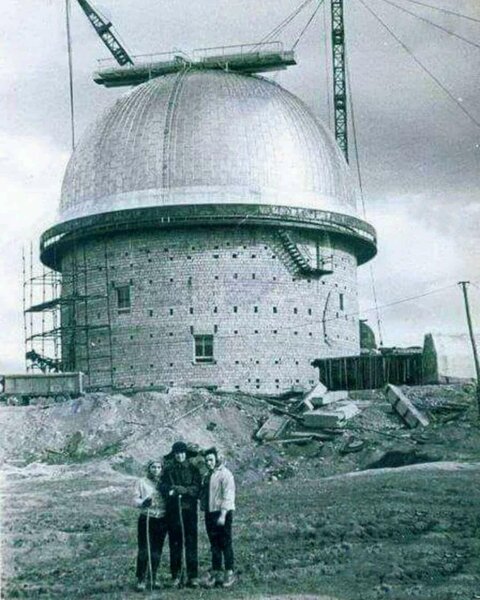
left=160, top=442, right=201, bottom=587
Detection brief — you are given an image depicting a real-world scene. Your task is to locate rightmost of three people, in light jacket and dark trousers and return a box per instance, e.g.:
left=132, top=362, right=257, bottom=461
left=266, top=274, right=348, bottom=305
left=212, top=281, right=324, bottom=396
left=201, top=448, right=236, bottom=588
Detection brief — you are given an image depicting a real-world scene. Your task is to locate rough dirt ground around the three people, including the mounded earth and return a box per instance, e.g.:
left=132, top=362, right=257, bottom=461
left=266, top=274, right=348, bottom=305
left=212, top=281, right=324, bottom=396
left=0, top=386, right=480, bottom=600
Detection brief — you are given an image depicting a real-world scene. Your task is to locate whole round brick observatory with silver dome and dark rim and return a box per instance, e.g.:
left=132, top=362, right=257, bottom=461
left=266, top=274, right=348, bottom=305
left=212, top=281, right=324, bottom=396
left=41, top=69, right=376, bottom=393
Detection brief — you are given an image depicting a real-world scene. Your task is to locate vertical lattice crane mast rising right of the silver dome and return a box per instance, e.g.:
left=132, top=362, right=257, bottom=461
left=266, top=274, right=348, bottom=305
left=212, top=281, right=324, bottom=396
left=331, top=0, right=348, bottom=162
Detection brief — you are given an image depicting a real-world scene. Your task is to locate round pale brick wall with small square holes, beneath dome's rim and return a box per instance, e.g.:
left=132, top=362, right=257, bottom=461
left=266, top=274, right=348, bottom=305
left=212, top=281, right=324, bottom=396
left=62, top=225, right=359, bottom=393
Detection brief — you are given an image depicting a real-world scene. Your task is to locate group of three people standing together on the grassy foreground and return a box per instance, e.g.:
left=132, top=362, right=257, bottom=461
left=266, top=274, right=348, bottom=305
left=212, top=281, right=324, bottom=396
left=135, top=442, right=235, bottom=591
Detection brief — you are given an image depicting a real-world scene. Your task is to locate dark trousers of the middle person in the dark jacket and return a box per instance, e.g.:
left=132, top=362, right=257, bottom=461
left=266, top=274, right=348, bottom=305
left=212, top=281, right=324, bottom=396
left=168, top=507, right=198, bottom=579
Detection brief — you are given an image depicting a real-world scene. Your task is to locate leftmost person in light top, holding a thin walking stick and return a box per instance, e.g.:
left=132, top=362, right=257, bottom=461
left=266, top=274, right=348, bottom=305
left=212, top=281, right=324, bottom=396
left=133, top=460, right=168, bottom=592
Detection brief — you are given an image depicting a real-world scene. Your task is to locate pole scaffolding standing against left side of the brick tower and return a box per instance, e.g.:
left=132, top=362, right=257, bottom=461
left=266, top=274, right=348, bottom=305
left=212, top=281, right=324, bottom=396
left=22, top=242, right=114, bottom=390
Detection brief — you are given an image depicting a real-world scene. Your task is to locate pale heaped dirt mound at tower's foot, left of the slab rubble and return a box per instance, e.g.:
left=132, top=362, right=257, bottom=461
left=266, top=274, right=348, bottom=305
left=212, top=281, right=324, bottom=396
left=0, top=389, right=300, bottom=483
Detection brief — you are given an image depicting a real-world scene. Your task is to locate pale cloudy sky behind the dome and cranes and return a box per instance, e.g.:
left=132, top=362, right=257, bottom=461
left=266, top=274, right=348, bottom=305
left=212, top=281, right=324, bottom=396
left=0, top=0, right=480, bottom=372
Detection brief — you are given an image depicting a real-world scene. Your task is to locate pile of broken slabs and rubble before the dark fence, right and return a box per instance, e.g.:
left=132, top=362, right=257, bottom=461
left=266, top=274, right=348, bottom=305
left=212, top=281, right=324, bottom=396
left=255, top=383, right=475, bottom=476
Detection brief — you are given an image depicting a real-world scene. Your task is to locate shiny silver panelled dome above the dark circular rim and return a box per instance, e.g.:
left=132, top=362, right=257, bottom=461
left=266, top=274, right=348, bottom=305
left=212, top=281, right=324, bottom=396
left=59, top=70, right=355, bottom=221
